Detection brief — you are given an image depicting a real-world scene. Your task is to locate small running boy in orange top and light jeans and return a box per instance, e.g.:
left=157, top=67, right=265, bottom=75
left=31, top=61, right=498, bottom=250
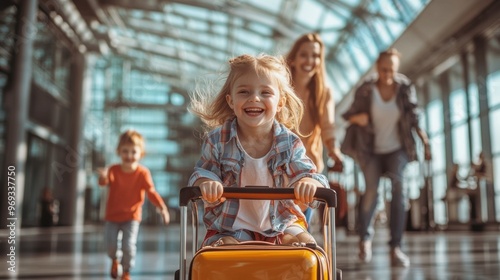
left=98, top=130, right=170, bottom=280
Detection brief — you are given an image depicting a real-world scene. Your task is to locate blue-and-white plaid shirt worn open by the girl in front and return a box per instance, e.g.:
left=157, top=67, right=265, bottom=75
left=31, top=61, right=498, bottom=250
left=189, top=118, right=329, bottom=236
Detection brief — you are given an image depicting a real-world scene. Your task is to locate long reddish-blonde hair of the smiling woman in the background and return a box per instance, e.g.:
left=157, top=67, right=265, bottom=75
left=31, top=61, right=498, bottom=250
left=286, top=33, right=327, bottom=123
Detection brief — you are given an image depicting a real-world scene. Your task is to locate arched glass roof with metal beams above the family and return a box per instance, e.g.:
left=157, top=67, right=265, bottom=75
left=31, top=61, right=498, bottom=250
left=92, top=0, right=429, bottom=100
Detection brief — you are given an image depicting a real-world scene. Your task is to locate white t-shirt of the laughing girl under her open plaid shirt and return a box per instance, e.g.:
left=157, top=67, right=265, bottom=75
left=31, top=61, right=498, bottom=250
left=233, top=138, right=274, bottom=233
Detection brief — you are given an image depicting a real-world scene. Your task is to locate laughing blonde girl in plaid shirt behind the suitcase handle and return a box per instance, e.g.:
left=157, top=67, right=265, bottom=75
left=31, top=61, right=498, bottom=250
left=189, top=55, right=328, bottom=245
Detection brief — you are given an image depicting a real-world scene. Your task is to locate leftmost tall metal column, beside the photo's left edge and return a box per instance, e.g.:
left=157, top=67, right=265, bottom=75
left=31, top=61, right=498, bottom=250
left=0, top=0, right=38, bottom=229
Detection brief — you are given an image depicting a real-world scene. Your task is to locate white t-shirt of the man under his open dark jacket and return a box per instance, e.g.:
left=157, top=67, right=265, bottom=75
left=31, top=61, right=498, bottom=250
left=370, top=85, right=401, bottom=154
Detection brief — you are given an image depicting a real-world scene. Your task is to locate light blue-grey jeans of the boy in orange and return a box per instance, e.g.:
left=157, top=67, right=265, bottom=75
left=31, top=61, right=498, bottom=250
left=104, top=221, right=140, bottom=272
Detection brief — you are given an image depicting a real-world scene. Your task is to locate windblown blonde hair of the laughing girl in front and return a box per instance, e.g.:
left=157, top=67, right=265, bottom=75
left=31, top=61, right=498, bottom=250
left=189, top=54, right=304, bottom=134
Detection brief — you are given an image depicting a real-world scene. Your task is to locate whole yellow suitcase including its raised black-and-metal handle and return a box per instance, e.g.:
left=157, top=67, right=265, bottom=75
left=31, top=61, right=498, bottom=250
left=176, top=187, right=342, bottom=280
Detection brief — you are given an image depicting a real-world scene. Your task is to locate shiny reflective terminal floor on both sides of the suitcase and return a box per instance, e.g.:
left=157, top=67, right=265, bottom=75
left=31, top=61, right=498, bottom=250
left=0, top=224, right=500, bottom=280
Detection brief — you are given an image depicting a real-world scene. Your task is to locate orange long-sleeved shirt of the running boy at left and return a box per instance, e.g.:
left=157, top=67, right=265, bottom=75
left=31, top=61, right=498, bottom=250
left=99, top=164, right=166, bottom=222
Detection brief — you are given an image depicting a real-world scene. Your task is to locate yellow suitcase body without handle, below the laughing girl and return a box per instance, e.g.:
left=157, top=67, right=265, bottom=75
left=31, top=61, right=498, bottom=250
left=190, top=242, right=329, bottom=280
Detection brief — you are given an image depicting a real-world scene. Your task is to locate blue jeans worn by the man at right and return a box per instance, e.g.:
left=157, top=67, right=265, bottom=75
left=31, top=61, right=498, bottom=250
left=358, top=149, right=408, bottom=247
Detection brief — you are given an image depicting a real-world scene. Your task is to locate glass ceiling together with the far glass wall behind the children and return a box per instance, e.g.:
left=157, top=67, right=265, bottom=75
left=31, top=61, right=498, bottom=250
left=78, top=0, right=430, bottom=201
